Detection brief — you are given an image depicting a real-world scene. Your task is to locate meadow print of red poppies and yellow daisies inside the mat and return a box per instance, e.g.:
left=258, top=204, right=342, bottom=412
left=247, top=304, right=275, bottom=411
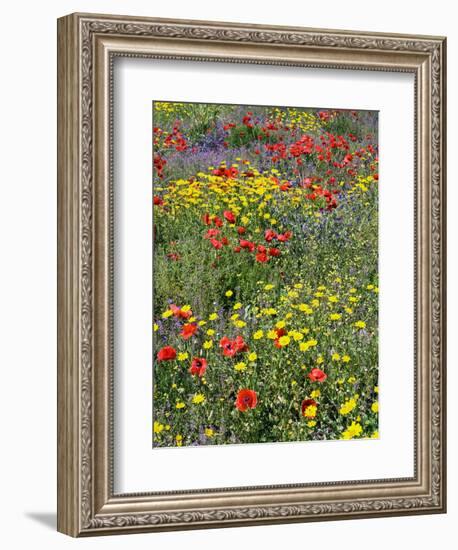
left=152, top=102, right=379, bottom=447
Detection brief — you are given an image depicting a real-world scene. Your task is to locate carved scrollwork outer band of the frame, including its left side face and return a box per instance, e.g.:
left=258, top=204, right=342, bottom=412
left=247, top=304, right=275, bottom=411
left=58, top=10, right=446, bottom=536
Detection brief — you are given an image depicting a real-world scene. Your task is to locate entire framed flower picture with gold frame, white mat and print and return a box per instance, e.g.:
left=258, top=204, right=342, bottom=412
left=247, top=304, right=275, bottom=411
left=58, top=14, right=446, bottom=536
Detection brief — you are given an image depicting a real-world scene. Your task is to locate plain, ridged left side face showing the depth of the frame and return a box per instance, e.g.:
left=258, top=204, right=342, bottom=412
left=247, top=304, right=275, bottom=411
left=57, top=12, right=81, bottom=537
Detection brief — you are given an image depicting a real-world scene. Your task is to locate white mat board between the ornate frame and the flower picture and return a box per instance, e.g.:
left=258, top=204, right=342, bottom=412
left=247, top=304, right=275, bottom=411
left=114, top=58, right=414, bottom=493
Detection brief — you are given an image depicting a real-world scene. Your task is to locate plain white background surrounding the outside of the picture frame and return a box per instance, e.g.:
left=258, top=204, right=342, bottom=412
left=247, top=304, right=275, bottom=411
left=0, top=0, right=458, bottom=550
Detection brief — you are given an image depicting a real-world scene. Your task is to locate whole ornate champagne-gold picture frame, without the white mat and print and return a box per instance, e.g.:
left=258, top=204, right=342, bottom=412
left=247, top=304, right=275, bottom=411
left=58, top=14, right=446, bottom=536
